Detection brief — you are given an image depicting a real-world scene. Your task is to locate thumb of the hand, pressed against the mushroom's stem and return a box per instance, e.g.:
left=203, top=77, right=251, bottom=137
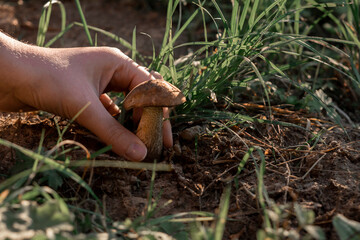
left=76, top=97, right=147, bottom=161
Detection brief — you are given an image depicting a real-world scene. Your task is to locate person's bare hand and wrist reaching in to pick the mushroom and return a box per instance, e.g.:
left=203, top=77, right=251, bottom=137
left=0, top=33, right=173, bottom=161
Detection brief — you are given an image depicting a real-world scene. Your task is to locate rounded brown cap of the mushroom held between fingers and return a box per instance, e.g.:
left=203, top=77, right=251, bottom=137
left=123, top=79, right=186, bottom=110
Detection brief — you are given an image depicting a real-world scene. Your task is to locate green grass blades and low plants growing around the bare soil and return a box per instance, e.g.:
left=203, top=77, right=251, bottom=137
left=0, top=0, right=360, bottom=239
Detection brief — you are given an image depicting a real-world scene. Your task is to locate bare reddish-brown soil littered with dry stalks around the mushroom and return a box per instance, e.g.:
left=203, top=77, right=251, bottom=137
left=0, top=1, right=360, bottom=239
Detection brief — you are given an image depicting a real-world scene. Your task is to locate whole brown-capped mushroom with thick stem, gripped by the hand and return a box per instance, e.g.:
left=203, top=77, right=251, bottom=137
left=123, top=79, right=186, bottom=159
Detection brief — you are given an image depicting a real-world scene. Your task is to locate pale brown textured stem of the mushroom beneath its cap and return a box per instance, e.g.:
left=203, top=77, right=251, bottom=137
left=136, top=107, right=163, bottom=159
